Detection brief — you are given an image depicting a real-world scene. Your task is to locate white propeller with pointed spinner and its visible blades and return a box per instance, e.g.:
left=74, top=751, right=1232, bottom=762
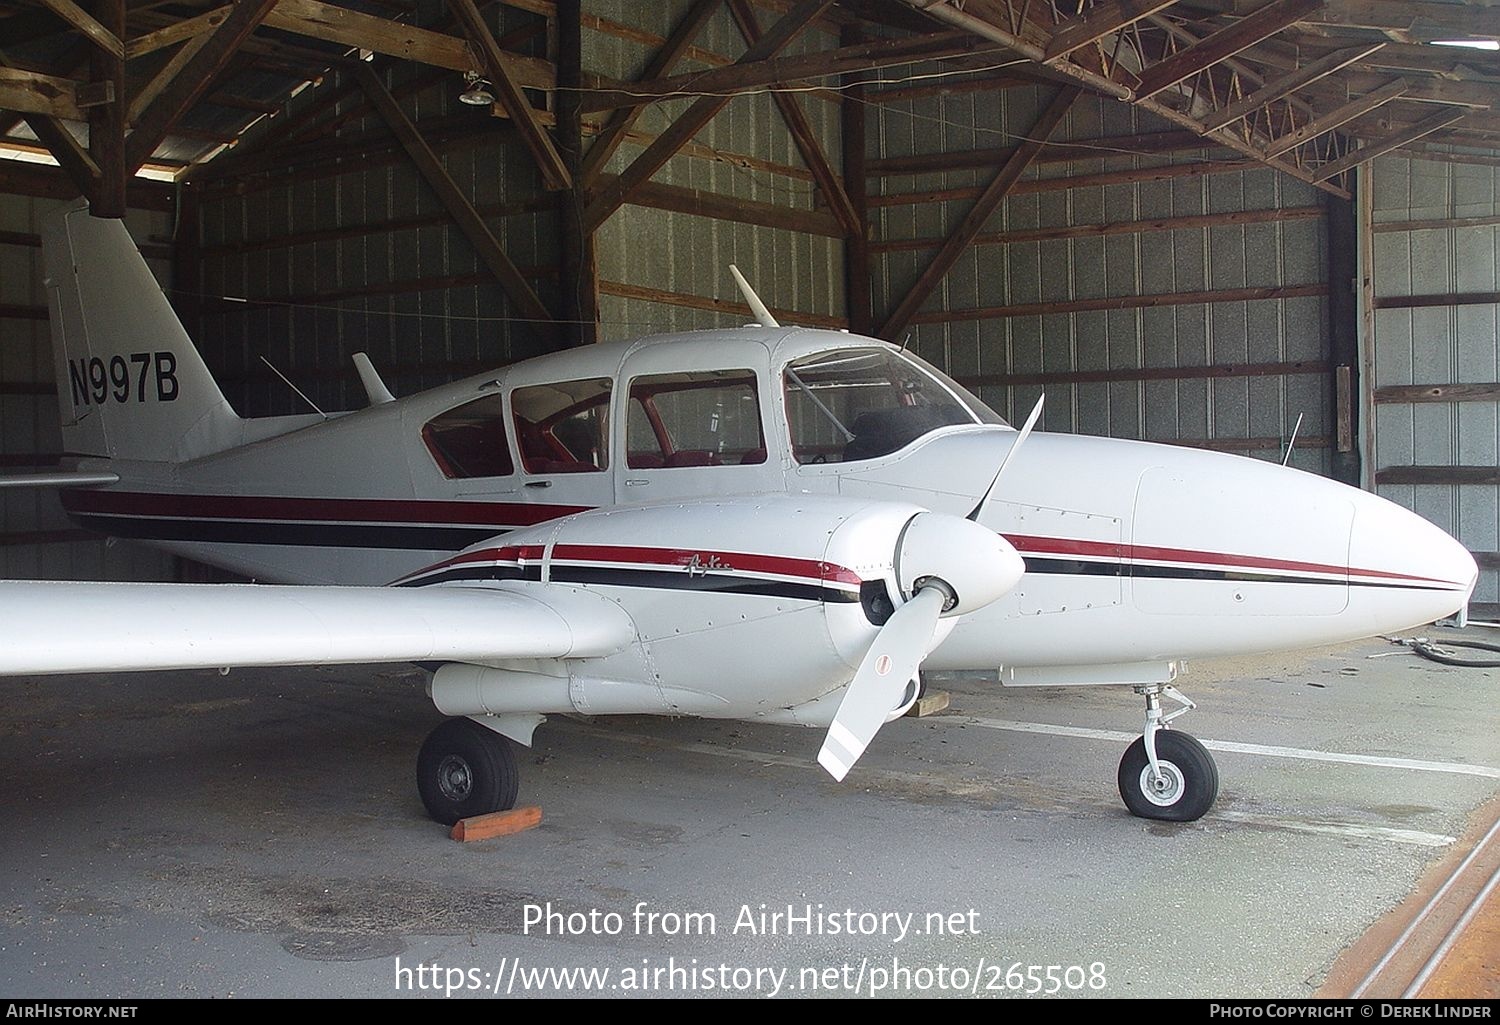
left=818, top=401, right=1043, bottom=780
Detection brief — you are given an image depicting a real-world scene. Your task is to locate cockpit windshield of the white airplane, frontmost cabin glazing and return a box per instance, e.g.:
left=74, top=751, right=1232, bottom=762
left=783, top=348, right=1005, bottom=464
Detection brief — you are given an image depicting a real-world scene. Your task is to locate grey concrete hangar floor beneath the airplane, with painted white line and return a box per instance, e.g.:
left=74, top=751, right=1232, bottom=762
left=0, top=629, right=1500, bottom=996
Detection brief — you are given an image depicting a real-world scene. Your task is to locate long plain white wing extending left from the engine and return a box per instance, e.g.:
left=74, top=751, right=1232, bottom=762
left=0, top=581, right=635, bottom=675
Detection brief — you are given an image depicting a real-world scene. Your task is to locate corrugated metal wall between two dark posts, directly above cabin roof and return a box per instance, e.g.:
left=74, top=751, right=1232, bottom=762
left=584, top=0, right=845, bottom=338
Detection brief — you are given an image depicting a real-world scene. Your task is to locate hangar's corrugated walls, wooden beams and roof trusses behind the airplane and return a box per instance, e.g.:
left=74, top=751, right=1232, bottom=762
left=0, top=0, right=1500, bottom=618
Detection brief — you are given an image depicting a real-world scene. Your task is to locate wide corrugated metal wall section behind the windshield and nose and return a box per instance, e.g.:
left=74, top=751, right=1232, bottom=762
left=867, top=86, right=1332, bottom=473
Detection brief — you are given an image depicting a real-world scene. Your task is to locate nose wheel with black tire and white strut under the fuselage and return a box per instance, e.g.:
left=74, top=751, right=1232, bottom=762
left=1118, top=684, right=1218, bottom=822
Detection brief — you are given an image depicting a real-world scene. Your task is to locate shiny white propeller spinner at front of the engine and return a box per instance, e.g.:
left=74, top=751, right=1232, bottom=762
left=896, top=512, right=1026, bottom=615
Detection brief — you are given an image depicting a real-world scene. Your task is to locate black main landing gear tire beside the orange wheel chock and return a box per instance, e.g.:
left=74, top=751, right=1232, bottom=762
left=417, top=719, right=521, bottom=825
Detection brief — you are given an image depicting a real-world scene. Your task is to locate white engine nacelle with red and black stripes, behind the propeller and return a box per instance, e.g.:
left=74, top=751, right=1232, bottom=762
left=410, top=495, right=948, bottom=717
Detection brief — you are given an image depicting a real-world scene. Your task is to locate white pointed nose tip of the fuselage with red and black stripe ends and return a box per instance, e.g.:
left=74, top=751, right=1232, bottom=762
left=1349, top=494, right=1479, bottom=633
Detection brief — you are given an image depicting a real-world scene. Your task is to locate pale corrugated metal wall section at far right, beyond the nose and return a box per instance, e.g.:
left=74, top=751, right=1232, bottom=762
left=1365, top=156, right=1500, bottom=602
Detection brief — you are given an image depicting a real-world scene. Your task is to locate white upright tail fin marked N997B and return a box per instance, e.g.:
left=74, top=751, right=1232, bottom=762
left=42, top=207, right=242, bottom=461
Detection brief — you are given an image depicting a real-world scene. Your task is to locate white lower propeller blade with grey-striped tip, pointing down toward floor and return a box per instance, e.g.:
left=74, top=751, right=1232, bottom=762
left=818, top=587, right=947, bottom=780
